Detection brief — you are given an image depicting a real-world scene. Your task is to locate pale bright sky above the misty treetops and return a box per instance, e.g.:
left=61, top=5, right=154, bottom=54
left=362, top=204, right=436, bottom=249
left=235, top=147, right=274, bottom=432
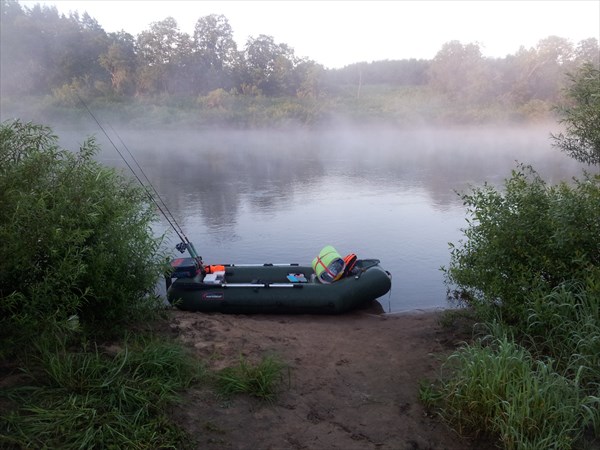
left=19, top=0, right=600, bottom=69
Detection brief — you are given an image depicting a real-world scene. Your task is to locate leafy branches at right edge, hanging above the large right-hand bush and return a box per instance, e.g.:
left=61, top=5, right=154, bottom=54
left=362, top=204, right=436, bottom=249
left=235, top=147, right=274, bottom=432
left=552, top=63, right=600, bottom=165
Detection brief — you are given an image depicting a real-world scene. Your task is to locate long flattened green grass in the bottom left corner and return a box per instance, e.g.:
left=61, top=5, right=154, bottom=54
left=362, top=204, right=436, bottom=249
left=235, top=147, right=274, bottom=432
left=0, top=336, right=204, bottom=449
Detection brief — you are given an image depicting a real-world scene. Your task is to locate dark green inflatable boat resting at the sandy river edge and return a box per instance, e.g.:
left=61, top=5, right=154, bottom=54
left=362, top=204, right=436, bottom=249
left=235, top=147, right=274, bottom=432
left=167, top=258, right=391, bottom=314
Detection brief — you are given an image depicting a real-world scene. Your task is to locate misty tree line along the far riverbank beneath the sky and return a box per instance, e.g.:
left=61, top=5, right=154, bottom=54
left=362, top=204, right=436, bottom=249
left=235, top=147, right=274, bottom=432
left=0, top=0, right=600, bottom=106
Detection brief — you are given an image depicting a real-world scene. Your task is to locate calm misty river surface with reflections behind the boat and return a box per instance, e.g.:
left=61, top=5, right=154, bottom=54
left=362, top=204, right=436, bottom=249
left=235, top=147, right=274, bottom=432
left=78, top=126, right=581, bottom=312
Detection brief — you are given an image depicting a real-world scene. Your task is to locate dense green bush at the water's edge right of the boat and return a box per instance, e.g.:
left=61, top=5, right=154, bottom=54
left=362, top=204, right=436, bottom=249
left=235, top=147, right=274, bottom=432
left=445, top=167, right=600, bottom=329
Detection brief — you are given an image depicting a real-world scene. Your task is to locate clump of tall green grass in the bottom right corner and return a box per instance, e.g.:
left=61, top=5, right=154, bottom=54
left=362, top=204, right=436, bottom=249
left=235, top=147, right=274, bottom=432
left=436, top=333, right=600, bottom=450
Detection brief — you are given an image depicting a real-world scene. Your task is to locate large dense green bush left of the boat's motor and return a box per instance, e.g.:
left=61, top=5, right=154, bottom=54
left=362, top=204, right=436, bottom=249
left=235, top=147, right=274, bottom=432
left=0, top=121, right=166, bottom=350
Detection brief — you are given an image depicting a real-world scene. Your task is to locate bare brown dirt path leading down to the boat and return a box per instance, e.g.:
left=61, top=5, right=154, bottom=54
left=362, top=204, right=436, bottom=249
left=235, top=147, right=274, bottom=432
left=166, top=310, right=474, bottom=450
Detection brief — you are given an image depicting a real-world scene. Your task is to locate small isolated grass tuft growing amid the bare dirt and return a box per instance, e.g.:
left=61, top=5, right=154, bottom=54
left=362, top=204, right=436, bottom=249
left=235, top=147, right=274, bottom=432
left=215, top=356, right=286, bottom=401
